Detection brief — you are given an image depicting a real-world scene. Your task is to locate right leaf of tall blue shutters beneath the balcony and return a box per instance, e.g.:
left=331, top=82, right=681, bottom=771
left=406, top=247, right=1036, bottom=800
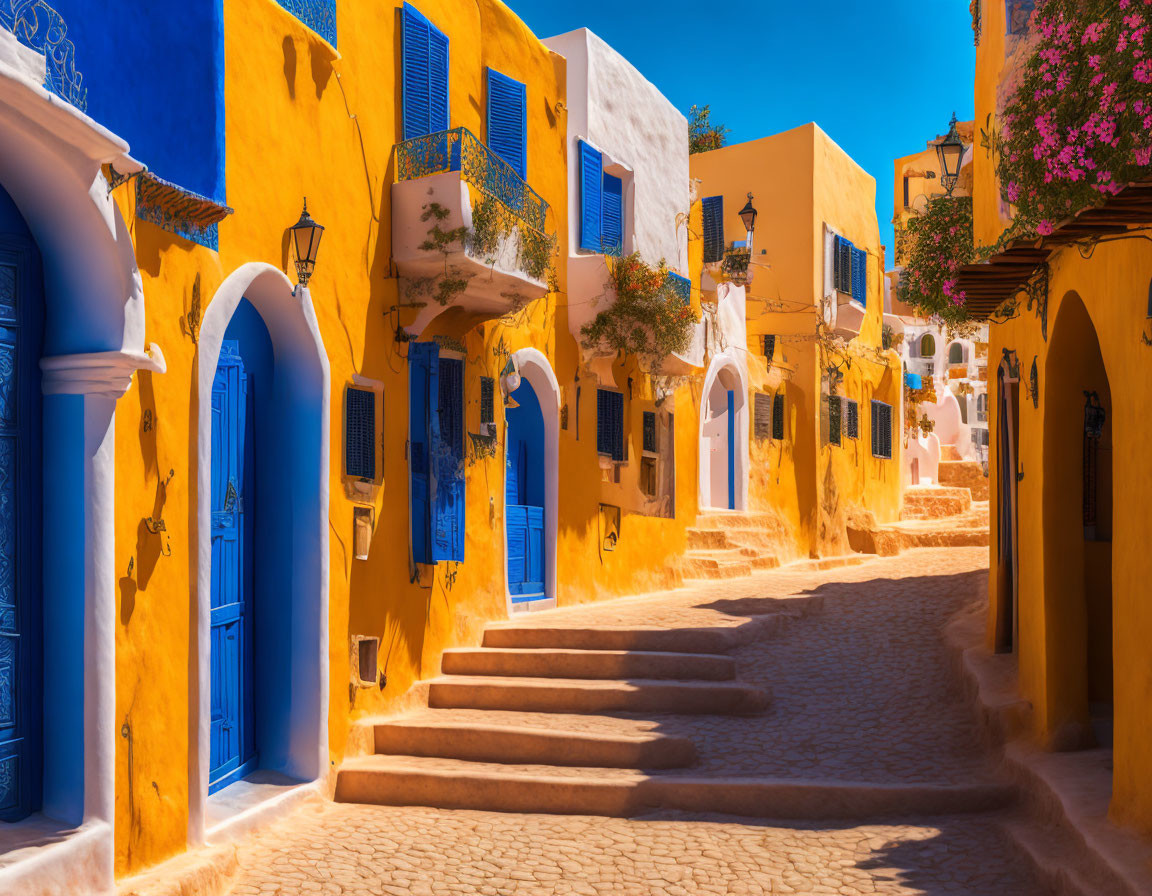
left=431, top=358, right=464, bottom=563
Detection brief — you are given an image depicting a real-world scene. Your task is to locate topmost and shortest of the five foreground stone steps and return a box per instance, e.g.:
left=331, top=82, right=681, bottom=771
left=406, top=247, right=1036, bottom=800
left=484, top=622, right=737, bottom=653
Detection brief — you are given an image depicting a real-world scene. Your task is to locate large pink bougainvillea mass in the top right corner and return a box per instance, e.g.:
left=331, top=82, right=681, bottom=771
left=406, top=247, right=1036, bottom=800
left=999, top=0, right=1152, bottom=235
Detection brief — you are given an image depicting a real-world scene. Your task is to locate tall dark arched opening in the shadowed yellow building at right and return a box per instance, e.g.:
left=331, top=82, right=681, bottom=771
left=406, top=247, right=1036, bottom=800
left=1043, top=293, right=1113, bottom=750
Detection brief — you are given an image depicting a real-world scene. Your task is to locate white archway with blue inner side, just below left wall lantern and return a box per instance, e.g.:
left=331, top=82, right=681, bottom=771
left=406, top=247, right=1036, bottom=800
left=189, top=264, right=329, bottom=843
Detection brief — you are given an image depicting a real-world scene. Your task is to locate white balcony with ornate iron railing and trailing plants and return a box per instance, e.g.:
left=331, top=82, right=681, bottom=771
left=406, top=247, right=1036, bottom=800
left=392, top=128, right=555, bottom=336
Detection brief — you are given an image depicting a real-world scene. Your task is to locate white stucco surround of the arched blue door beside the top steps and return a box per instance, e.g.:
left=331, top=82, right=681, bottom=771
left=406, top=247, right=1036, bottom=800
left=500, top=349, right=561, bottom=616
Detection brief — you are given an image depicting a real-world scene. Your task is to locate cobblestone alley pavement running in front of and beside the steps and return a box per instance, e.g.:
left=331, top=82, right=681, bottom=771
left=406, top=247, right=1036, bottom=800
left=209, top=548, right=1047, bottom=896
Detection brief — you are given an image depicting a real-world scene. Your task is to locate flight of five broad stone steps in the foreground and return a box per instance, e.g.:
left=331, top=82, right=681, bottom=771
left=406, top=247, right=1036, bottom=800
left=335, top=623, right=768, bottom=815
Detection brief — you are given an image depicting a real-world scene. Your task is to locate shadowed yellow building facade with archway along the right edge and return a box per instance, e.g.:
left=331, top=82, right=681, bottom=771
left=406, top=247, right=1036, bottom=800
left=961, top=3, right=1152, bottom=834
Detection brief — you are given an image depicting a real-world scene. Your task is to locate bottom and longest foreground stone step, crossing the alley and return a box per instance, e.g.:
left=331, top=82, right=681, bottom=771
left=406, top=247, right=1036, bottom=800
left=335, top=755, right=1013, bottom=820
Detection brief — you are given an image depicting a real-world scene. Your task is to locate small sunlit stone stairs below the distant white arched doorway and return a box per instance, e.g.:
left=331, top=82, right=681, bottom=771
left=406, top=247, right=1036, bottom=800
left=681, top=510, right=787, bottom=580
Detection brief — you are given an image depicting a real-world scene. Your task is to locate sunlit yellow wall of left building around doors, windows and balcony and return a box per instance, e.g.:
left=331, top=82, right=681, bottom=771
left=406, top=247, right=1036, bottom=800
left=115, top=0, right=700, bottom=874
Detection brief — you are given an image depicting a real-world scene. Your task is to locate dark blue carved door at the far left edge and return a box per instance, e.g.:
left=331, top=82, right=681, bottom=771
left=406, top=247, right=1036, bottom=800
left=0, top=189, right=44, bottom=821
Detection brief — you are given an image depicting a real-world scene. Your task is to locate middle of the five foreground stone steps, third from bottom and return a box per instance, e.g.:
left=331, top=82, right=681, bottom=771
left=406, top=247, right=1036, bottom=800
left=429, top=675, right=768, bottom=715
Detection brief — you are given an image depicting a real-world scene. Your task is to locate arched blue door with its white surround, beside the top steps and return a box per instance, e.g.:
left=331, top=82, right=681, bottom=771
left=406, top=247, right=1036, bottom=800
left=505, top=349, right=560, bottom=614
